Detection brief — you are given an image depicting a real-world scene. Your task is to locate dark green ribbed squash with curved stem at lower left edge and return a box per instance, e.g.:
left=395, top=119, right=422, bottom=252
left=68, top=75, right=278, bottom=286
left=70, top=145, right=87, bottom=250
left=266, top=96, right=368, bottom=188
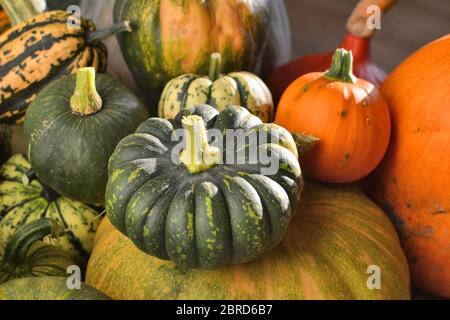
left=0, top=218, right=76, bottom=284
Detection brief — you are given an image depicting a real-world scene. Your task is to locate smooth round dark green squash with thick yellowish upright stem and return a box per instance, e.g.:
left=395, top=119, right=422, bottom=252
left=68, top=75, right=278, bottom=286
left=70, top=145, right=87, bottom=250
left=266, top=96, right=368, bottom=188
left=24, top=69, right=148, bottom=204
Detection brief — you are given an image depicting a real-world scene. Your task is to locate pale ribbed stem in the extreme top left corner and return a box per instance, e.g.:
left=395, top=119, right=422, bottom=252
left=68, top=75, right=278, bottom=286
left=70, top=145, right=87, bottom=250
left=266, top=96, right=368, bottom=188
left=0, top=0, right=47, bottom=26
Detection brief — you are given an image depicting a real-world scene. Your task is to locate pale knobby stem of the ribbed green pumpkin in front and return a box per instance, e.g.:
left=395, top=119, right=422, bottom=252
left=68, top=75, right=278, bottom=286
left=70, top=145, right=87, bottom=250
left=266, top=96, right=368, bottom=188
left=180, top=115, right=221, bottom=174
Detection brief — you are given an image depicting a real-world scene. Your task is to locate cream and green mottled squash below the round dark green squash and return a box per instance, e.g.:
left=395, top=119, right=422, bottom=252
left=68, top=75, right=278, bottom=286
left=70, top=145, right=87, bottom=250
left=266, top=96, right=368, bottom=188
left=0, top=155, right=100, bottom=264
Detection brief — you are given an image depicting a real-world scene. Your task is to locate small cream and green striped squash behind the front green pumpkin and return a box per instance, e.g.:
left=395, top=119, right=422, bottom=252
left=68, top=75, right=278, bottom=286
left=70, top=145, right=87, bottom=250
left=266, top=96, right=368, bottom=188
left=158, top=53, right=274, bottom=123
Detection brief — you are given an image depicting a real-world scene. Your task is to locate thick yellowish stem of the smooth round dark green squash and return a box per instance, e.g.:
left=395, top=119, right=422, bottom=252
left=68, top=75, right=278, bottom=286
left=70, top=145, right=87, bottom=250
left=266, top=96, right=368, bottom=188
left=70, top=67, right=103, bottom=116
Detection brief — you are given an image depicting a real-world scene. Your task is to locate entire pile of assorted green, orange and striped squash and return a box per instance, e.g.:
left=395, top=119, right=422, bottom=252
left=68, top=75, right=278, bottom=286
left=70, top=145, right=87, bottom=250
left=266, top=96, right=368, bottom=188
left=0, top=0, right=450, bottom=299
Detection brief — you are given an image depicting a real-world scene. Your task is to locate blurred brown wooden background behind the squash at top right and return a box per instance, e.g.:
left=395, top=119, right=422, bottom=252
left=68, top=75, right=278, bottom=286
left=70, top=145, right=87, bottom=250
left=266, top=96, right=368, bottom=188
left=284, top=0, right=450, bottom=71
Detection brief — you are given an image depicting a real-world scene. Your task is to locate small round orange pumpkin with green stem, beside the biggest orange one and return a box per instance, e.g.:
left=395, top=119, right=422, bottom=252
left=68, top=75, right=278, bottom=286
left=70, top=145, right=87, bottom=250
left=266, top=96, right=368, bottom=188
left=275, top=49, right=391, bottom=183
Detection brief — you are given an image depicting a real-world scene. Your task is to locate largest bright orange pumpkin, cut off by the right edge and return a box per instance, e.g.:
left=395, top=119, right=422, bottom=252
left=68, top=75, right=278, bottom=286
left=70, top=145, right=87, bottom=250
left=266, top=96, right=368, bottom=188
left=372, top=35, right=450, bottom=298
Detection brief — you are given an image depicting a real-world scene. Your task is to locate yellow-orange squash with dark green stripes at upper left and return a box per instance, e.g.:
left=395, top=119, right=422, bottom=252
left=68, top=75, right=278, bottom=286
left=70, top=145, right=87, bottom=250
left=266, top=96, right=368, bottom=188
left=0, top=11, right=129, bottom=124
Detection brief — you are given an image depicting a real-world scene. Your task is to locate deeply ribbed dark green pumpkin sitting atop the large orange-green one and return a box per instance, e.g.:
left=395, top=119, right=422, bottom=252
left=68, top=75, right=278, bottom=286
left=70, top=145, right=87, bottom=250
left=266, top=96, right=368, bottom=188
left=106, top=105, right=302, bottom=268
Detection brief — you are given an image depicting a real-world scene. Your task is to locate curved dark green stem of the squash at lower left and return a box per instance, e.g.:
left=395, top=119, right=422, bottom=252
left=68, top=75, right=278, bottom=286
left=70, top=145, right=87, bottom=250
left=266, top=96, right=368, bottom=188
left=0, top=218, right=64, bottom=283
